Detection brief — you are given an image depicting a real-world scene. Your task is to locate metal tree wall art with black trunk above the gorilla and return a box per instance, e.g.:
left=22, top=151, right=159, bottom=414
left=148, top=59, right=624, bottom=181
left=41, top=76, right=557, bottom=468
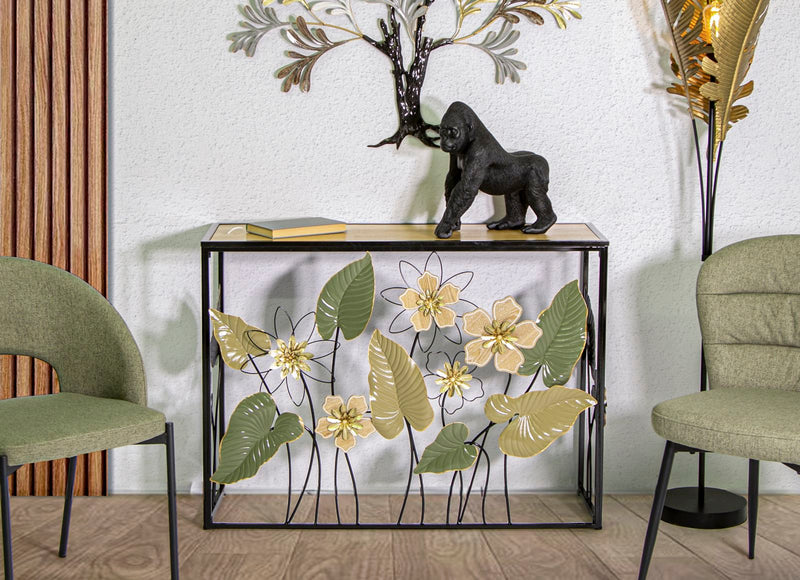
left=228, top=0, right=581, bottom=147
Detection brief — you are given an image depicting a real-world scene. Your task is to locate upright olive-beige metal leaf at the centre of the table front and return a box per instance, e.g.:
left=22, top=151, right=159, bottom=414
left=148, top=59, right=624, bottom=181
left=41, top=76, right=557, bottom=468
left=369, top=330, right=433, bottom=439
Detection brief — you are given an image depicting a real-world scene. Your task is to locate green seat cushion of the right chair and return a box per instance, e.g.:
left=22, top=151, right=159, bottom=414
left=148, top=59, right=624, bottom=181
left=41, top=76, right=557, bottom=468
left=652, top=389, right=800, bottom=463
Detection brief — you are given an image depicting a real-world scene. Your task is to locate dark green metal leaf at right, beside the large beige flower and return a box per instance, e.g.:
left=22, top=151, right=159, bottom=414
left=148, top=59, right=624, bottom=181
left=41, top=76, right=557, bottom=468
left=519, top=280, right=588, bottom=387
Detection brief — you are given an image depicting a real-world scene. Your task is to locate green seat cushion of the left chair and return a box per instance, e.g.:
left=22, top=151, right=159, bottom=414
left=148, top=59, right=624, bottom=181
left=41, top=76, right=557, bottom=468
left=0, top=393, right=165, bottom=465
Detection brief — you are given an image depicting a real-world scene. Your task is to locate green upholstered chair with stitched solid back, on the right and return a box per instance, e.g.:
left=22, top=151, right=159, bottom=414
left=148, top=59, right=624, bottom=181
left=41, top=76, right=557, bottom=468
left=639, top=235, right=800, bottom=578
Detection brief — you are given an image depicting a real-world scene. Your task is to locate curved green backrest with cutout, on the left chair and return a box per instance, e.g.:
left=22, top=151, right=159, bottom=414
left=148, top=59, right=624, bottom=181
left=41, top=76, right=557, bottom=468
left=0, top=257, right=147, bottom=405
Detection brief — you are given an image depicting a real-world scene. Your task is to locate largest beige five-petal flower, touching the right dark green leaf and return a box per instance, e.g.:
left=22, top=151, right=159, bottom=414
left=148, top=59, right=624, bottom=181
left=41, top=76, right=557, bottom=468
left=464, top=296, right=542, bottom=373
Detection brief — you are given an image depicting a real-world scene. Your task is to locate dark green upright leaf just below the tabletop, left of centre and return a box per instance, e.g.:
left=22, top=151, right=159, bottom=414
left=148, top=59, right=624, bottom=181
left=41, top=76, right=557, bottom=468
left=317, top=252, right=375, bottom=340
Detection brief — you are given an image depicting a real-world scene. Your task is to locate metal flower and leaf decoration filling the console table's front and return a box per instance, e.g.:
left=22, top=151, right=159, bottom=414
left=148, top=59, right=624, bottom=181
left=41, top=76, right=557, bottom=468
left=211, top=253, right=597, bottom=526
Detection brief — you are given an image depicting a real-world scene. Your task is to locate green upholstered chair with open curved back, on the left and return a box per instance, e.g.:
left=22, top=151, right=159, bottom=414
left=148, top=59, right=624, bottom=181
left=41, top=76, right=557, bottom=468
left=0, top=257, right=178, bottom=580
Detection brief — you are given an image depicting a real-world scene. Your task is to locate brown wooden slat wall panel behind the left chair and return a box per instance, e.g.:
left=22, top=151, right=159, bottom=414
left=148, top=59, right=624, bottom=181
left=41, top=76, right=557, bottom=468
left=0, top=0, right=108, bottom=495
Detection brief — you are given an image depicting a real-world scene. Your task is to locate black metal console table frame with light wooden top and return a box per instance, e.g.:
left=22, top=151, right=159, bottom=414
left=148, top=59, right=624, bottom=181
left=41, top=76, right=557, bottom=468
left=200, top=223, right=609, bottom=529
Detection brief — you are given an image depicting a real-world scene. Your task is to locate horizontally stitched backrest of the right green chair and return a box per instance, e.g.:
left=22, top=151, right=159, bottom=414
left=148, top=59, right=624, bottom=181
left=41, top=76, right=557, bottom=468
left=697, top=235, right=800, bottom=391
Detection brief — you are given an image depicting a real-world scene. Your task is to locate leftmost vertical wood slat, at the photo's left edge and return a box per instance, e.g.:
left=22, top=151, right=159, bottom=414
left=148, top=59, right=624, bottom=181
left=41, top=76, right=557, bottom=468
left=0, top=0, right=17, bottom=493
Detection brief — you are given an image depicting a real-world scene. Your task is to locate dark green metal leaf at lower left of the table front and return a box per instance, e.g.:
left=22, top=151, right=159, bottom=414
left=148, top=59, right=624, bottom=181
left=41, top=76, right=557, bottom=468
left=211, top=393, right=303, bottom=483
